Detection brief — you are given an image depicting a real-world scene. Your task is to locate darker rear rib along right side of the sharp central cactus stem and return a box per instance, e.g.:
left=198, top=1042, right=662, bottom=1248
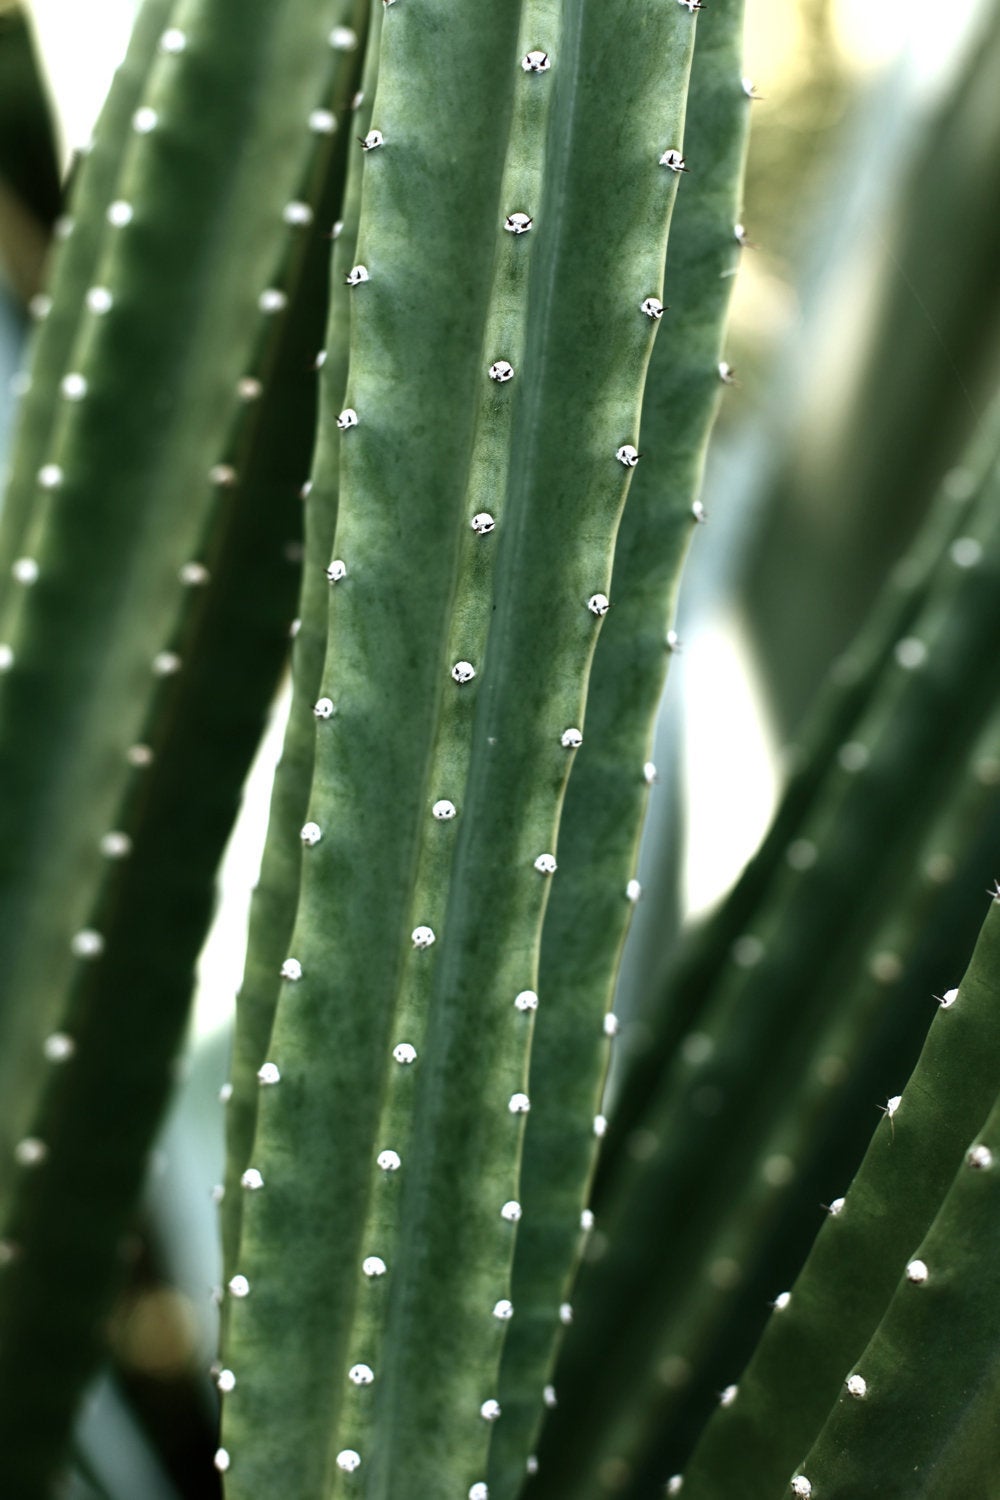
left=490, top=0, right=750, bottom=1496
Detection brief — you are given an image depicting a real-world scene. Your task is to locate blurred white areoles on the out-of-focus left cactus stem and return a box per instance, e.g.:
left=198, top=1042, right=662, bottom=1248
left=0, top=8, right=357, bottom=1302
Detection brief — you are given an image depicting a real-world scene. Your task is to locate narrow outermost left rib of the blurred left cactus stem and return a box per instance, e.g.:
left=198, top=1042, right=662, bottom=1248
left=0, top=0, right=180, bottom=579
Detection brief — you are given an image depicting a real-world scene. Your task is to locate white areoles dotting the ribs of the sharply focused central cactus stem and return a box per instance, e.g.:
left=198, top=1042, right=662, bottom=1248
left=230, top=0, right=734, bottom=1500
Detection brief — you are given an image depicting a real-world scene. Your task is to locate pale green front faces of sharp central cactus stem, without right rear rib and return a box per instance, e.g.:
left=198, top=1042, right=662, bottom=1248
left=220, top=5, right=719, bottom=1500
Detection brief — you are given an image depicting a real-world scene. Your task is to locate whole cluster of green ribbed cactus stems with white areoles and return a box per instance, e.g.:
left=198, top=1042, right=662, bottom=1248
left=0, top=0, right=1000, bottom=1500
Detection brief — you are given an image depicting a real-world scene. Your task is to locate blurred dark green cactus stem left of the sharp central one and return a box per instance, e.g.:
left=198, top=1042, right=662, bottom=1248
left=0, top=3, right=364, bottom=1500
